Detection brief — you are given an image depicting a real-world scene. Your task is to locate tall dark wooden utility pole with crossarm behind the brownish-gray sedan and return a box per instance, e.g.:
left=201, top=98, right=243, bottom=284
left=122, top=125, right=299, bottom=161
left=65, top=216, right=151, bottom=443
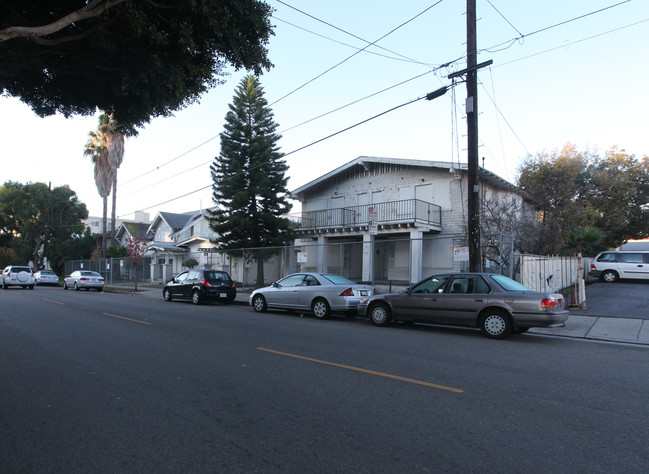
left=448, top=0, right=493, bottom=272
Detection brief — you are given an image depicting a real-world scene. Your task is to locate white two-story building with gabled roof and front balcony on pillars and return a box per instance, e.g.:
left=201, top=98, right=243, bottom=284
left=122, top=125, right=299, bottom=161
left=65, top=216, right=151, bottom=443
left=291, top=156, right=522, bottom=283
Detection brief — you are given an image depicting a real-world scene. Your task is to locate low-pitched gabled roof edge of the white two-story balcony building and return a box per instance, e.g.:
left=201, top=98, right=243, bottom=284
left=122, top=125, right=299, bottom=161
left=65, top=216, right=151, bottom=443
left=291, top=156, right=516, bottom=198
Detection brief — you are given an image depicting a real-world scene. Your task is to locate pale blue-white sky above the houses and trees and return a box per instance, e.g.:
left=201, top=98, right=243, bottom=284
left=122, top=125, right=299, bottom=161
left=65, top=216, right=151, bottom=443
left=0, top=0, right=649, bottom=219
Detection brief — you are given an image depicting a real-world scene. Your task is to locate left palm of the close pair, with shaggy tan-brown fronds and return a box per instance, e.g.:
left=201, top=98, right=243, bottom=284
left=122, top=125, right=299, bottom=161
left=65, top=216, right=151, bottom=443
left=83, top=114, right=114, bottom=258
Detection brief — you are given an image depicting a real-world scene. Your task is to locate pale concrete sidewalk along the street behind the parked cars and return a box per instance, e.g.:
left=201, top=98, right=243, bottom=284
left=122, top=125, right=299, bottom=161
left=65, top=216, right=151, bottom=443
left=106, top=284, right=649, bottom=346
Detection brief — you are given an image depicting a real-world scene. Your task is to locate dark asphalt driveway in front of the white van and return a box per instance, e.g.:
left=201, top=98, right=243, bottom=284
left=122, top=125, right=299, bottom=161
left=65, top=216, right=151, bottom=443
left=570, top=280, right=649, bottom=319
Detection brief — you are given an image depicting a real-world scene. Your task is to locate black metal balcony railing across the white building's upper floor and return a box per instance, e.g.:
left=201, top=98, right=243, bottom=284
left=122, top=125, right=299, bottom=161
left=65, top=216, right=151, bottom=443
left=291, top=199, right=442, bottom=230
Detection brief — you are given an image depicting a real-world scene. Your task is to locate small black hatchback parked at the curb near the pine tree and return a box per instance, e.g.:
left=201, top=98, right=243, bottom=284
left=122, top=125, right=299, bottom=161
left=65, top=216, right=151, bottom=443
left=162, top=269, right=237, bottom=304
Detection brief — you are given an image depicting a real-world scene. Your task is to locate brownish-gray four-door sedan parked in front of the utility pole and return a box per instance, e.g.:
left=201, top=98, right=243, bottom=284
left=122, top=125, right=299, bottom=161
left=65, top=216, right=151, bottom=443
left=358, top=273, right=568, bottom=339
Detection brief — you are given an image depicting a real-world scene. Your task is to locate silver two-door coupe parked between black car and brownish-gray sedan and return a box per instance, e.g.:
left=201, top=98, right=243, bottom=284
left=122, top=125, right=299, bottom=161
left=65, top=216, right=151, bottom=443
left=250, top=273, right=374, bottom=319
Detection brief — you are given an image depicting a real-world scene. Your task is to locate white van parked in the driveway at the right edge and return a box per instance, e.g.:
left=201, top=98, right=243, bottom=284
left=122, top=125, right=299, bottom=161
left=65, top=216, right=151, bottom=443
left=590, top=251, right=649, bottom=282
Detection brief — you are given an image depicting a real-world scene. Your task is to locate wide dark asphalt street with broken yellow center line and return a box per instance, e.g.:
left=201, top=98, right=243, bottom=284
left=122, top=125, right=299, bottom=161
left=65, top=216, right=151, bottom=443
left=0, top=288, right=649, bottom=473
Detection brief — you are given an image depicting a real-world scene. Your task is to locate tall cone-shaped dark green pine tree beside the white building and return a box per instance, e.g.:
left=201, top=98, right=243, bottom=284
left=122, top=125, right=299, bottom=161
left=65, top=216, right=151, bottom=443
left=208, top=75, right=291, bottom=287
